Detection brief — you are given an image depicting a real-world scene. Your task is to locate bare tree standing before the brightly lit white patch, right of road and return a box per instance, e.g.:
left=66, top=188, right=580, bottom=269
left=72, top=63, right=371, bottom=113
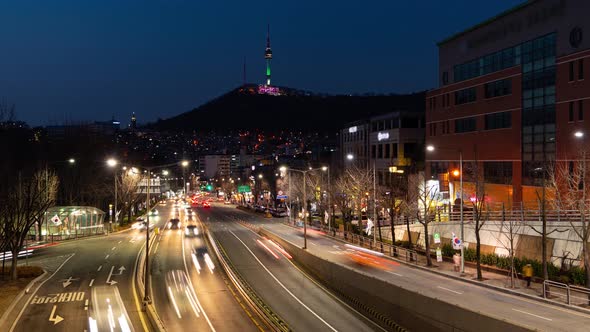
left=406, top=173, right=439, bottom=266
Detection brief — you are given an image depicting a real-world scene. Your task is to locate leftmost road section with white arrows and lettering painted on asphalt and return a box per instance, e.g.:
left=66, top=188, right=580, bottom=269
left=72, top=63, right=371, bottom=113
left=7, top=217, right=161, bottom=331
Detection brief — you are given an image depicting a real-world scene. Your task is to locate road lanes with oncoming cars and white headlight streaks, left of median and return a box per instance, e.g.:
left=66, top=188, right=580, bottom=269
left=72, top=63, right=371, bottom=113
left=151, top=200, right=258, bottom=331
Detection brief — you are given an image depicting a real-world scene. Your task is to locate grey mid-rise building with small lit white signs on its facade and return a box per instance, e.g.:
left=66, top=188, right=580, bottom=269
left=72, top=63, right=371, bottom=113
left=340, top=110, right=424, bottom=185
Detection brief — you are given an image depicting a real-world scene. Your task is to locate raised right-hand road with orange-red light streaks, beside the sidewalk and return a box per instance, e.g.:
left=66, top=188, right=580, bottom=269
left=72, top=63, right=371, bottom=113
left=209, top=206, right=590, bottom=331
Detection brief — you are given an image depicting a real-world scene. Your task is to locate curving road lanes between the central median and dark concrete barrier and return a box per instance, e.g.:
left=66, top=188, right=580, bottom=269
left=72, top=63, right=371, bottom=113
left=197, top=204, right=382, bottom=331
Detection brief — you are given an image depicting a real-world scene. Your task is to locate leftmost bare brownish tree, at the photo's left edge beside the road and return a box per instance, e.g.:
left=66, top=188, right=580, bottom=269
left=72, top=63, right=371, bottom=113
left=0, top=170, right=58, bottom=280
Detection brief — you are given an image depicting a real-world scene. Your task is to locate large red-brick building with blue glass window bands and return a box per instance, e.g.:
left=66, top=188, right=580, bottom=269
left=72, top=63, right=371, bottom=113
left=426, top=0, right=590, bottom=202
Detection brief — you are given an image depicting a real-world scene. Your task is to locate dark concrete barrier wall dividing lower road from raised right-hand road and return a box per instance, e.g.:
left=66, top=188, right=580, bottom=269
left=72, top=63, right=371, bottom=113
left=259, top=229, right=529, bottom=332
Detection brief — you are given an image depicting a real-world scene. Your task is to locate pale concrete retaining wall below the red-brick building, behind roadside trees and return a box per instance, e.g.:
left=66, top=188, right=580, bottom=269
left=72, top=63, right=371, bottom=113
left=381, top=222, right=582, bottom=266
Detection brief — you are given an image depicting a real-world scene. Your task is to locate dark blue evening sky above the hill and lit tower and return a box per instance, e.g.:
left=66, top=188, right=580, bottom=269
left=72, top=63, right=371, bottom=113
left=0, top=0, right=522, bottom=125
